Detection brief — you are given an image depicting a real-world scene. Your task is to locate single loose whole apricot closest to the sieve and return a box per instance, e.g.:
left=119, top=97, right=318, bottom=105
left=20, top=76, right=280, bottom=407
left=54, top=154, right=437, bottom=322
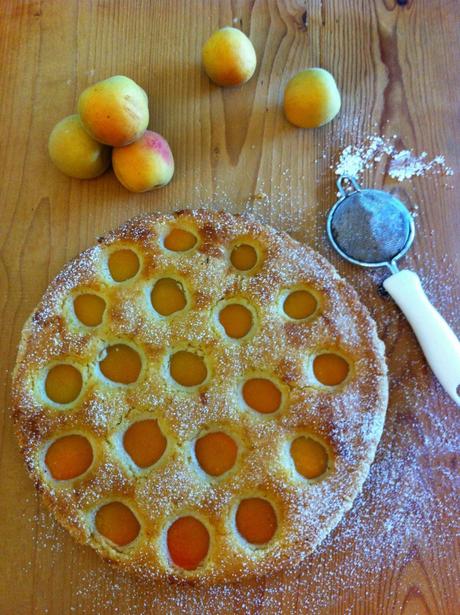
left=284, top=68, right=341, bottom=128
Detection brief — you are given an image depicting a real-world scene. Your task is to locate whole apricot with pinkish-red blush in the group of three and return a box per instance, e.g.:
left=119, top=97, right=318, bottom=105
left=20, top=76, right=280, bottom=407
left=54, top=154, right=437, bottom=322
left=112, top=130, right=174, bottom=192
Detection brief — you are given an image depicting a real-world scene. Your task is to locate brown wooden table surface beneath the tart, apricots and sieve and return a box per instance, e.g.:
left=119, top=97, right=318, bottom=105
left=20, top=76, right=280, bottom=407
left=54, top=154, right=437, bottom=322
left=0, top=0, right=460, bottom=615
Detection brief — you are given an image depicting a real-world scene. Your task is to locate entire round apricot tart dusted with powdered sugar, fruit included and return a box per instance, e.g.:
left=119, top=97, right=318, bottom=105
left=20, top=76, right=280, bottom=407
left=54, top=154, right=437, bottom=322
left=13, top=210, right=387, bottom=583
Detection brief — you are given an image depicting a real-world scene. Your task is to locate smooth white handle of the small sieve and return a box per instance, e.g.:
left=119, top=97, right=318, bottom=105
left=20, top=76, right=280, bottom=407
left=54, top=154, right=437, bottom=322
left=383, top=269, right=460, bottom=405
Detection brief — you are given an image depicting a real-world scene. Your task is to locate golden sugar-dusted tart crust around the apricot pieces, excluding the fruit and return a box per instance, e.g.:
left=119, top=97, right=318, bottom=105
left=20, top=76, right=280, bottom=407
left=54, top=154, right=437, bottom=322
left=12, top=210, right=387, bottom=583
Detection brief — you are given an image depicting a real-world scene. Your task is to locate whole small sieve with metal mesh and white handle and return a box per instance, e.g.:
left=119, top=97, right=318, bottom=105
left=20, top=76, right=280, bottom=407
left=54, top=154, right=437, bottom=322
left=326, top=175, right=460, bottom=404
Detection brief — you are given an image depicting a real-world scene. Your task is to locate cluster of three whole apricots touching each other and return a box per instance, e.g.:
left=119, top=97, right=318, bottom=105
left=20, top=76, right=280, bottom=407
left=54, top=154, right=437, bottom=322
left=48, top=75, right=174, bottom=192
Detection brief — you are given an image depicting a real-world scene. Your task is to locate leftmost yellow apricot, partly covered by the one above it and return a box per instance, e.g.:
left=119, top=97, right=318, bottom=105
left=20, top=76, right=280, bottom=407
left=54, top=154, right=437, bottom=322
left=48, top=115, right=110, bottom=179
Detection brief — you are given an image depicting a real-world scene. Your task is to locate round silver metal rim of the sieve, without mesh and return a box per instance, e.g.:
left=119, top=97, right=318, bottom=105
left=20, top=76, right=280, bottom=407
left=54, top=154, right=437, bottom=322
left=326, top=175, right=415, bottom=273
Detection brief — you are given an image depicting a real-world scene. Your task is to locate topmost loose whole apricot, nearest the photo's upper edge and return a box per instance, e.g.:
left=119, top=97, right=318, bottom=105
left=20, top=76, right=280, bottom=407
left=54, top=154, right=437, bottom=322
left=202, top=27, right=257, bottom=86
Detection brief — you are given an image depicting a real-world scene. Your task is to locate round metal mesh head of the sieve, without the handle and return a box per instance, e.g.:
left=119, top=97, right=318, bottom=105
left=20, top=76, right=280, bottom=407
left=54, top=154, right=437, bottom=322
left=327, top=175, right=415, bottom=272
